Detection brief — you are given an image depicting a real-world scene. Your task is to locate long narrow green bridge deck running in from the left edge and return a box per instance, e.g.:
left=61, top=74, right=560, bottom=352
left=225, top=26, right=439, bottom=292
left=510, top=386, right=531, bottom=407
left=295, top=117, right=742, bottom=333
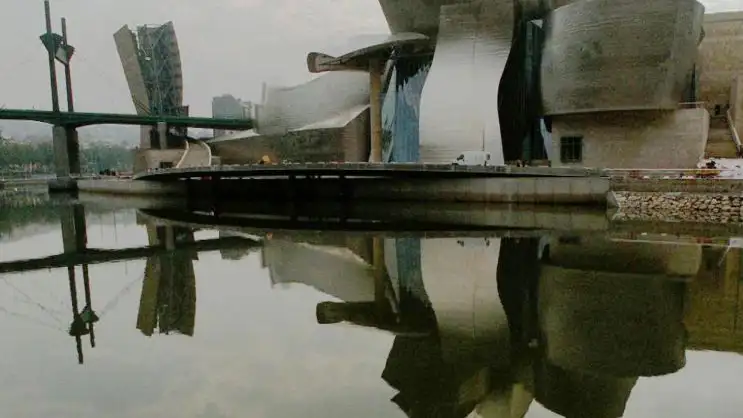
left=0, top=109, right=253, bottom=130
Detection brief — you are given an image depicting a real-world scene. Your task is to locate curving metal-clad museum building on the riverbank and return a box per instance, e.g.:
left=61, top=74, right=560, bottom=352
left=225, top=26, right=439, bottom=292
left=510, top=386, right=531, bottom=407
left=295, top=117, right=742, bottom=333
left=116, top=0, right=743, bottom=168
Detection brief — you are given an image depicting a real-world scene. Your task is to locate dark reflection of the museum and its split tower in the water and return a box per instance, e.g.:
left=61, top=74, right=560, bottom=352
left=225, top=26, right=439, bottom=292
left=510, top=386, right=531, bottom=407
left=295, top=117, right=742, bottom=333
left=4, top=201, right=743, bottom=417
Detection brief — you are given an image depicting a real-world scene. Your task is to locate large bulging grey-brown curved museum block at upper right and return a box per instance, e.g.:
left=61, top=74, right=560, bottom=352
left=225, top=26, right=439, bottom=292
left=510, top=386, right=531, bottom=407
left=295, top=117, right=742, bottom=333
left=541, top=0, right=704, bottom=115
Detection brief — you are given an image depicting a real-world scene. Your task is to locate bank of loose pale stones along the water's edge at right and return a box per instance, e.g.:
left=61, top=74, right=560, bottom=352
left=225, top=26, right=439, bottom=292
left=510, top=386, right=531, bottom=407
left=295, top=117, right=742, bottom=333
left=613, top=192, right=743, bottom=224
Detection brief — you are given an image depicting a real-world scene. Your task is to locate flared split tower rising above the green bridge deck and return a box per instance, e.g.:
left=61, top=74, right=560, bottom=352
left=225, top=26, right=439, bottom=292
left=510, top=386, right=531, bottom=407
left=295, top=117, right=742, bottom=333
left=114, top=22, right=187, bottom=115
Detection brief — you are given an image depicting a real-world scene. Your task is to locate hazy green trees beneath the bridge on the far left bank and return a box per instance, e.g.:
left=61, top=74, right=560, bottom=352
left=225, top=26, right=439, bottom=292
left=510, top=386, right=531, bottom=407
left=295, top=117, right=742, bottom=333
left=0, top=136, right=132, bottom=177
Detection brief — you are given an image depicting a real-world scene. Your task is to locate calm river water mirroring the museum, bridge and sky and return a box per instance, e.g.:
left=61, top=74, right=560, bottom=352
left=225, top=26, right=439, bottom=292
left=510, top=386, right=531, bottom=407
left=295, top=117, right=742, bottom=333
left=0, top=191, right=743, bottom=418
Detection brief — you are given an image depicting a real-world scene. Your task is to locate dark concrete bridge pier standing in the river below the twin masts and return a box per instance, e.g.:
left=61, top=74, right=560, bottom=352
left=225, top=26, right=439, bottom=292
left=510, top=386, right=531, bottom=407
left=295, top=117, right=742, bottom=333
left=49, top=125, right=80, bottom=191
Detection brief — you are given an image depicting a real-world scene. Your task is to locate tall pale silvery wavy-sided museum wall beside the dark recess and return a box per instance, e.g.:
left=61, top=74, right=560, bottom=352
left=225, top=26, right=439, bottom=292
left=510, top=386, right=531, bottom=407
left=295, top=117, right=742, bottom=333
left=420, top=0, right=514, bottom=165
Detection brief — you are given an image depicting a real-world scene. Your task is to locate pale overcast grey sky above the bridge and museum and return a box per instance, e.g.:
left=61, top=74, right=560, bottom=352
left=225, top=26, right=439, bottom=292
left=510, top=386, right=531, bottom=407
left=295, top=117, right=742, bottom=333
left=0, top=0, right=741, bottom=119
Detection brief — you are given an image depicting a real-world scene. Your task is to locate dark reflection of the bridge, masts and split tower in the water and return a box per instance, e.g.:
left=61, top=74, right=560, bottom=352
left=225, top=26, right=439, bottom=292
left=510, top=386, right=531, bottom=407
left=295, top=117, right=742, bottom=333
left=0, top=204, right=259, bottom=364
